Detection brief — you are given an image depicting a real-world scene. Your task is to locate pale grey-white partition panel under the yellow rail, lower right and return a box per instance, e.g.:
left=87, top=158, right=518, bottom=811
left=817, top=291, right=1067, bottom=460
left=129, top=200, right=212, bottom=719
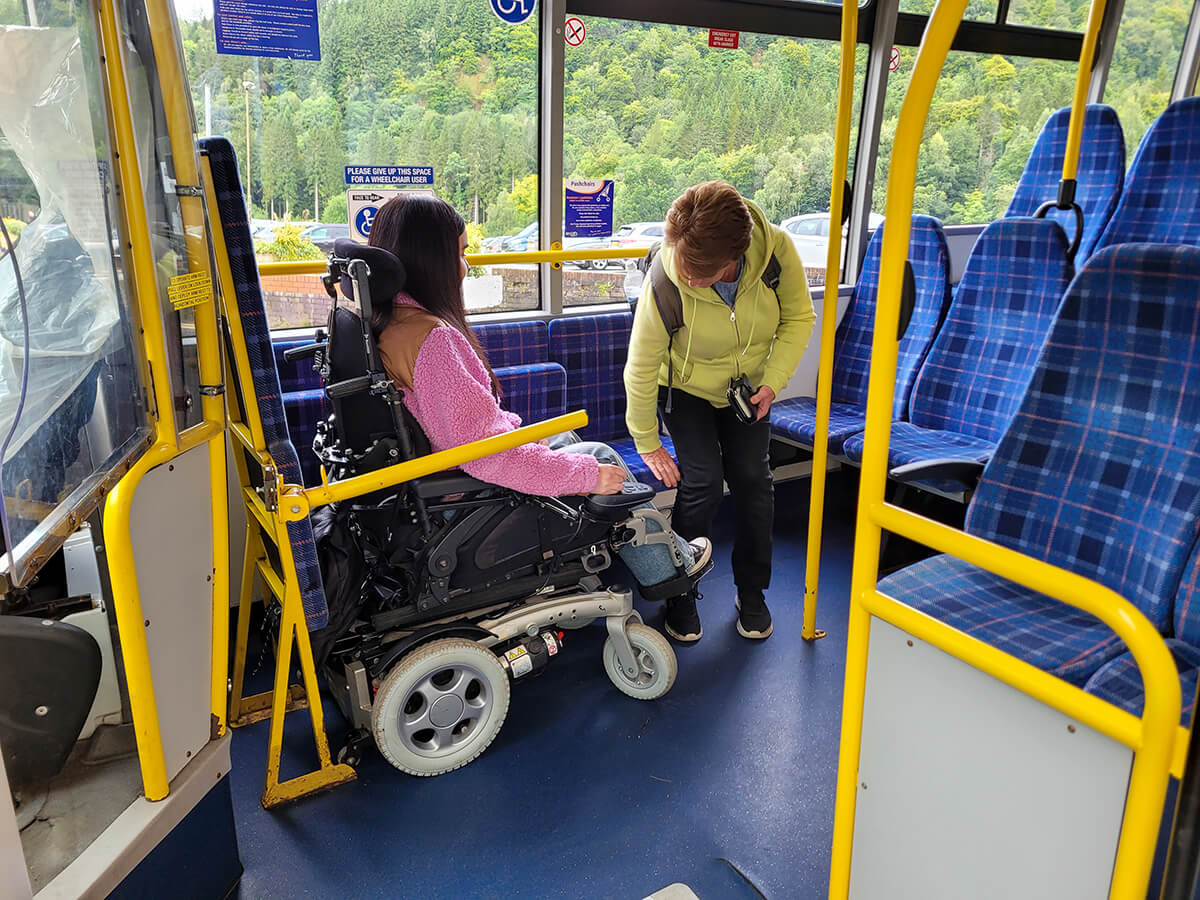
left=851, top=619, right=1133, bottom=900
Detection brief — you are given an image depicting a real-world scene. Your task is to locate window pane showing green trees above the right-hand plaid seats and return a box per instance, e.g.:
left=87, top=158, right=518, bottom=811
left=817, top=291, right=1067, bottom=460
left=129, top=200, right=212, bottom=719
left=874, top=47, right=1076, bottom=224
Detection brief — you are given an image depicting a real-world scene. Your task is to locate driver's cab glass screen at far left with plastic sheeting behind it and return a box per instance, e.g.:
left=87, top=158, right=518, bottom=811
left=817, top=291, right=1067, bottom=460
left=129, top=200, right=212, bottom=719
left=0, top=0, right=149, bottom=581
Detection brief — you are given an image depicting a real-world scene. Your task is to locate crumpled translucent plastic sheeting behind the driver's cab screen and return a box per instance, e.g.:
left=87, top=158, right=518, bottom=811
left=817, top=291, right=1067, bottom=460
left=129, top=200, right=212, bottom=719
left=0, top=26, right=120, bottom=465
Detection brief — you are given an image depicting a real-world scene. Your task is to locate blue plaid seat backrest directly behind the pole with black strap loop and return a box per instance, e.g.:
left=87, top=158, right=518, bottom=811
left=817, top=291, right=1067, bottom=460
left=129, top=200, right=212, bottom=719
left=1004, top=103, right=1124, bottom=265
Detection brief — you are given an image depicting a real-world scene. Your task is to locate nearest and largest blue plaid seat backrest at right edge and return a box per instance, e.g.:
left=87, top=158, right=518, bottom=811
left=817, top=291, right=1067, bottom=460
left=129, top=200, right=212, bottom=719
left=966, top=244, right=1200, bottom=630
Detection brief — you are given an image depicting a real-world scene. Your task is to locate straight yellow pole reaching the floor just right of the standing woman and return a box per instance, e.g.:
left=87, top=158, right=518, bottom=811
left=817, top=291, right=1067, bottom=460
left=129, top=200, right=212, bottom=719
left=800, top=2, right=858, bottom=641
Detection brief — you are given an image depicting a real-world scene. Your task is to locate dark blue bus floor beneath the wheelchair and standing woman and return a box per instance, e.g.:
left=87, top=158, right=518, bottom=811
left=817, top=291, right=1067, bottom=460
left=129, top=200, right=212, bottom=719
left=226, top=474, right=853, bottom=900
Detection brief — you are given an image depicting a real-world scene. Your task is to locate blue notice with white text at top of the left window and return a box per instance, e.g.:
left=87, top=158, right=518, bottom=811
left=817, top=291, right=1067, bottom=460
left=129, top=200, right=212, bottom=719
left=212, top=0, right=320, bottom=60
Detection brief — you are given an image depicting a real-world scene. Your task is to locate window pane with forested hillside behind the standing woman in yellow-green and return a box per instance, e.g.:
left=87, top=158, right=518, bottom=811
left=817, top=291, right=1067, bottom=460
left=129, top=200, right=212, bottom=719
left=563, top=17, right=866, bottom=294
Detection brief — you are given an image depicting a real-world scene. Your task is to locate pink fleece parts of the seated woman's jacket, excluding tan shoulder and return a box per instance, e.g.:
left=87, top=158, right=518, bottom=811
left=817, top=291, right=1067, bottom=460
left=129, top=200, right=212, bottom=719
left=396, top=303, right=600, bottom=497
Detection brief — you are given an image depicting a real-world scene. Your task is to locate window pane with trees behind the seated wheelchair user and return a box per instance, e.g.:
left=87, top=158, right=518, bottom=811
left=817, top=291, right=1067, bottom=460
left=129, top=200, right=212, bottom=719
left=175, top=0, right=541, bottom=316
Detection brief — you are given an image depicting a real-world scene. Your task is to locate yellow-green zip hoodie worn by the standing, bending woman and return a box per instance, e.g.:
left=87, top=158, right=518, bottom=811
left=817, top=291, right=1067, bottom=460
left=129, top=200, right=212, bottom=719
left=625, top=200, right=816, bottom=454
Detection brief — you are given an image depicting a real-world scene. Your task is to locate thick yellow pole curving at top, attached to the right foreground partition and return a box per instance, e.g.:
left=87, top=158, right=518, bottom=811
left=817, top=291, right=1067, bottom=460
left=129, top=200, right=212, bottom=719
left=829, top=0, right=966, bottom=898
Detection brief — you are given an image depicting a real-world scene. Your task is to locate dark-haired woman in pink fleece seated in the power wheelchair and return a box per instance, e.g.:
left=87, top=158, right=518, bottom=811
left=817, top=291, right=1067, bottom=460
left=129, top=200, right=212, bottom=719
left=370, top=196, right=712, bottom=586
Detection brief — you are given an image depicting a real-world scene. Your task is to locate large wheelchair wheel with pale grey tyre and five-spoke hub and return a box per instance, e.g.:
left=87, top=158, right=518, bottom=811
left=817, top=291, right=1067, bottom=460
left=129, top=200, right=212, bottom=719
left=371, top=637, right=510, bottom=775
